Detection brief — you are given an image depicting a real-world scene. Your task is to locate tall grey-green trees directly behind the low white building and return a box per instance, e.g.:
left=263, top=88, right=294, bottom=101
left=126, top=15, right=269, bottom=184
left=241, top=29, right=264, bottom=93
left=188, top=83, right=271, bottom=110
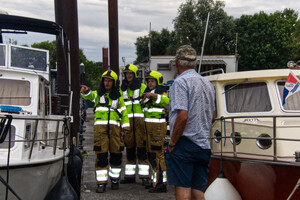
left=135, top=0, right=235, bottom=63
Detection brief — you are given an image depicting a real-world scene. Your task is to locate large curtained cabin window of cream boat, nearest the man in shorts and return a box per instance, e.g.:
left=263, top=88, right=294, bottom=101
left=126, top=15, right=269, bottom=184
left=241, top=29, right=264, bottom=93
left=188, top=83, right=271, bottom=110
left=225, top=83, right=272, bottom=113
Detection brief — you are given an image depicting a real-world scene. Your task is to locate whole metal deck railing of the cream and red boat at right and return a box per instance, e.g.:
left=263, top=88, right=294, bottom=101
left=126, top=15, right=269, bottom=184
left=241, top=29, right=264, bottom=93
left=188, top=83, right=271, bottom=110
left=209, top=115, right=300, bottom=161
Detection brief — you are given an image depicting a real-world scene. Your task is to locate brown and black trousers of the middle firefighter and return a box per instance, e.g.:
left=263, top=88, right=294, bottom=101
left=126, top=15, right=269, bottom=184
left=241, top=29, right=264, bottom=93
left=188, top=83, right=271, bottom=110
left=124, top=117, right=150, bottom=178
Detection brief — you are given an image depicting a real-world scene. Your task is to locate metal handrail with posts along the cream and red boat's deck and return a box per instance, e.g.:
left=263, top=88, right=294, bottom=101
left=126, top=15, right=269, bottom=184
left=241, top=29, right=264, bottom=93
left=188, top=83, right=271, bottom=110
left=213, top=115, right=300, bottom=161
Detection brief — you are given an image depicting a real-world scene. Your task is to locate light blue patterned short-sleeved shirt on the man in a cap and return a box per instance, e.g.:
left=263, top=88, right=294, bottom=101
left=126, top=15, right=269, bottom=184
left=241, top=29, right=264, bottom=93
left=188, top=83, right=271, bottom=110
left=169, top=69, right=215, bottom=149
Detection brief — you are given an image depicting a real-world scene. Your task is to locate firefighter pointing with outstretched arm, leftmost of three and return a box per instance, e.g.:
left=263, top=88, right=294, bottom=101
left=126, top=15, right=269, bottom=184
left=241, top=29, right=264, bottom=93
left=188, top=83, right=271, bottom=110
left=81, top=70, right=130, bottom=193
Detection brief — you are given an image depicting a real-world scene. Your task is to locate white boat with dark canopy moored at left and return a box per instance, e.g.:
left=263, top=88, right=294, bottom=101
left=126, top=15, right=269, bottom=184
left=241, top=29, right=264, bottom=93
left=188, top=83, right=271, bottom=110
left=0, top=14, right=72, bottom=200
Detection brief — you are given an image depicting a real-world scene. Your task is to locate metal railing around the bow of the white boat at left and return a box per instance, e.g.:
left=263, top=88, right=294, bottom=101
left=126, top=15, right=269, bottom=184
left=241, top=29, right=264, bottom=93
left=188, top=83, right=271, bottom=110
left=0, top=115, right=71, bottom=160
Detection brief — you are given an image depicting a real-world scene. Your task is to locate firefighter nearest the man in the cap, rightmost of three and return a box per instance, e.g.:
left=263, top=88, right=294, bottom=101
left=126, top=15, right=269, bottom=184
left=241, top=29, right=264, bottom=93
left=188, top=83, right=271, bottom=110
left=143, top=71, right=169, bottom=193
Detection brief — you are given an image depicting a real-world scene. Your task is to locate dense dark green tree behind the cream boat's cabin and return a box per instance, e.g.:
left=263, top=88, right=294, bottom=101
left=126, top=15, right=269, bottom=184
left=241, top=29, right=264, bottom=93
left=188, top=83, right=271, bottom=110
left=236, top=9, right=299, bottom=70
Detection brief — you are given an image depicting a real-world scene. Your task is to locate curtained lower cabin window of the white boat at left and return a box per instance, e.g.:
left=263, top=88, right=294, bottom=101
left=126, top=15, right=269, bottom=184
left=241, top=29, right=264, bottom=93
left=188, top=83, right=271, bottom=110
left=0, top=79, right=31, bottom=106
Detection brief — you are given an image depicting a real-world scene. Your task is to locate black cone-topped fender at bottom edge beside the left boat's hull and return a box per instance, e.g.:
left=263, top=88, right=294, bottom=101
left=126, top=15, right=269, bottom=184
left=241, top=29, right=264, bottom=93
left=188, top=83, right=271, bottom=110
left=45, top=175, right=78, bottom=200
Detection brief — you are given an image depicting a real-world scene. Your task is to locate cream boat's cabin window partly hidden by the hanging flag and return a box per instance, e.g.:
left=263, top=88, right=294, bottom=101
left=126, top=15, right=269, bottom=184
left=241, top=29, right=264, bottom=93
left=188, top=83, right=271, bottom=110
left=277, top=81, right=300, bottom=111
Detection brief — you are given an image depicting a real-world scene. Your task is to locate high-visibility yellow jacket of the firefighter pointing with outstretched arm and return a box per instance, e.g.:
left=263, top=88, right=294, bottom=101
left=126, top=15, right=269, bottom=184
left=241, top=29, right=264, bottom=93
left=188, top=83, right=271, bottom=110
left=81, top=91, right=130, bottom=130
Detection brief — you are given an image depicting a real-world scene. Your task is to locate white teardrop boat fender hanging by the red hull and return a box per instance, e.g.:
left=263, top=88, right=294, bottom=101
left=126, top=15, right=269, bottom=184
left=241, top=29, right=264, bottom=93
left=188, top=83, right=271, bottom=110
left=204, top=177, right=242, bottom=200
